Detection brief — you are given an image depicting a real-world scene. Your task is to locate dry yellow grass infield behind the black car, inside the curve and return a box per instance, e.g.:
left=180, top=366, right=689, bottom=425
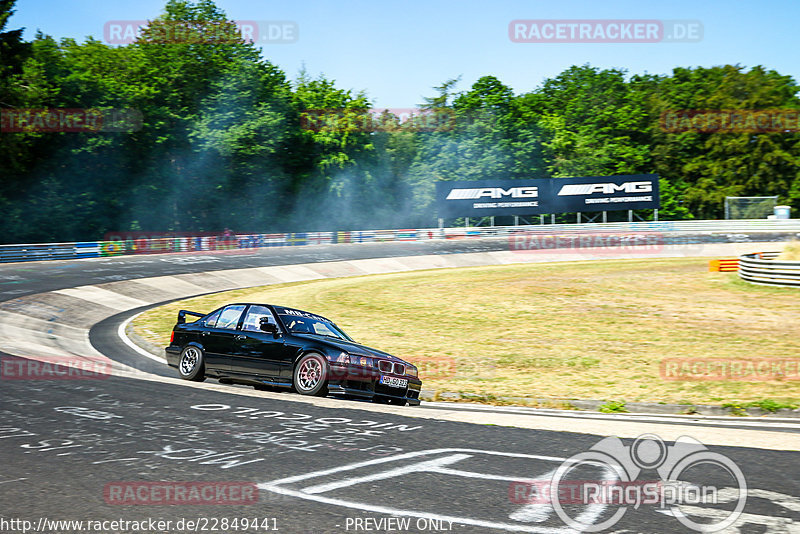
left=135, top=259, right=800, bottom=404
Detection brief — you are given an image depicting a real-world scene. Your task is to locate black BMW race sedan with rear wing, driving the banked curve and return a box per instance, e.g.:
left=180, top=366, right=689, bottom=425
left=166, top=304, right=422, bottom=405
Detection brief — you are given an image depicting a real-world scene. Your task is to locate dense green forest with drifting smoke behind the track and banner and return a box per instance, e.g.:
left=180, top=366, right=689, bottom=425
left=0, top=0, right=800, bottom=242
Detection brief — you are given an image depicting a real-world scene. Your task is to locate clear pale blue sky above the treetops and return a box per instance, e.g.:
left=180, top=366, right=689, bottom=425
left=6, top=0, right=800, bottom=109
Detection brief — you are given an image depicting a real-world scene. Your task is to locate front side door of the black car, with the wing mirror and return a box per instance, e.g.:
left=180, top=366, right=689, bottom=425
left=231, top=304, right=287, bottom=379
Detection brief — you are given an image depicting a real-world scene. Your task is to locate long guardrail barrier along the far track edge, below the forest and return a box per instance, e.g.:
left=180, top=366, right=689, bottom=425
left=0, top=219, right=800, bottom=263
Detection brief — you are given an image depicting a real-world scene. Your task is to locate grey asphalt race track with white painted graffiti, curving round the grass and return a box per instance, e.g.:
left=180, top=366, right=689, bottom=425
left=0, top=239, right=800, bottom=533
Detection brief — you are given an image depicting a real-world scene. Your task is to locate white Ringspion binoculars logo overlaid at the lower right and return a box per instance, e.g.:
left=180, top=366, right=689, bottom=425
left=508, top=434, right=747, bottom=532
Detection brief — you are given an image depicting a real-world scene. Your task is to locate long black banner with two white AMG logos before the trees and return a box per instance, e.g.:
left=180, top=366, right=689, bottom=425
left=436, top=174, right=661, bottom=218
